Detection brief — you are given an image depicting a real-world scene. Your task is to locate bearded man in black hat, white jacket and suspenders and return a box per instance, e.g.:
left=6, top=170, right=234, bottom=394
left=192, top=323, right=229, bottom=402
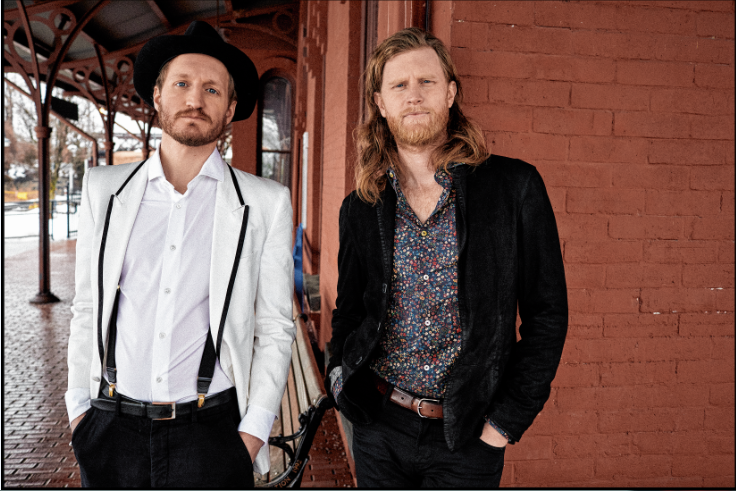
left=66, top=21, right=295, bottom=488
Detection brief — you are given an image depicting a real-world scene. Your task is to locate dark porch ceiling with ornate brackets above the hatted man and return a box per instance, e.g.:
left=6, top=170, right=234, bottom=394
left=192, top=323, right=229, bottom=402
left=2, top=0, right=299, bottom=119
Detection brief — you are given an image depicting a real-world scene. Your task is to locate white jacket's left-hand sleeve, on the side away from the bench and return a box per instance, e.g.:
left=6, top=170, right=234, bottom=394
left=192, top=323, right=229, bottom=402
left=66, top=169, right=96, bottom=417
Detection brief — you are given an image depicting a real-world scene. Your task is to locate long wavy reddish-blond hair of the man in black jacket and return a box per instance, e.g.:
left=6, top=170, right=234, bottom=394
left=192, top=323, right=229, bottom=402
left=353, top=27, right=488, bottom=204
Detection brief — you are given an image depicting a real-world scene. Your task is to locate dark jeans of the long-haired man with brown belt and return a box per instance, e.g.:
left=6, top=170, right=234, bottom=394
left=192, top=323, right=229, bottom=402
left=353, top=402, right=505, bottom=489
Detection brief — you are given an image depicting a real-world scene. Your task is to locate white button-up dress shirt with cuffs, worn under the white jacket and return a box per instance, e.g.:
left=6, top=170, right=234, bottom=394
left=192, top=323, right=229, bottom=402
left=66, top=150, right=276, bottom=442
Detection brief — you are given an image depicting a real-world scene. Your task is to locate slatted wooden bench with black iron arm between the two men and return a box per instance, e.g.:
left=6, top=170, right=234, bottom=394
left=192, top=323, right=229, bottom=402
left=255, top=304, right=330, bottom=488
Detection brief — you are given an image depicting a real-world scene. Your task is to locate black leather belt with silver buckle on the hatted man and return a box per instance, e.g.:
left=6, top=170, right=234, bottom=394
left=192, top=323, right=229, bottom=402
left=91, top=382, right=235, bottom=420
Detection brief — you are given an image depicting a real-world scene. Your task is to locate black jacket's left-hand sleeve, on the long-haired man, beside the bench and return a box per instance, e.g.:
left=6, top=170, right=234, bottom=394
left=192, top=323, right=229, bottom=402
left=325, top=194, right=367, bottom=403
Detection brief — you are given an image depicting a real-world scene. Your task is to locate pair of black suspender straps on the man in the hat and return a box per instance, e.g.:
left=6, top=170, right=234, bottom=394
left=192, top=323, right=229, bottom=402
left=97, top=162, right=249, bottom=407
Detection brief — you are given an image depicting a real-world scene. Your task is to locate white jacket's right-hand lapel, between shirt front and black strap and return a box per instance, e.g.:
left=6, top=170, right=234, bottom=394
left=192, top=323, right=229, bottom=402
left=210, top=168, right=245, bottom=356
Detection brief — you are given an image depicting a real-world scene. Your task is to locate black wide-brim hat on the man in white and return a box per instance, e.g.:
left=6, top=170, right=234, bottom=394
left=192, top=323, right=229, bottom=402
left=133, top=20, right=258, bottom=121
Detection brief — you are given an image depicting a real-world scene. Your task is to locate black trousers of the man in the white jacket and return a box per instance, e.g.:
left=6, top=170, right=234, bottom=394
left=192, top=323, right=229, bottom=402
left=72, top=389, right=253, bottom=489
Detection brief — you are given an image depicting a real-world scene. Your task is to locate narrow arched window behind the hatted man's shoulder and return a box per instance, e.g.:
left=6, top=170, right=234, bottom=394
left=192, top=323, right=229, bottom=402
left=259, top=77, right=291, bottom=187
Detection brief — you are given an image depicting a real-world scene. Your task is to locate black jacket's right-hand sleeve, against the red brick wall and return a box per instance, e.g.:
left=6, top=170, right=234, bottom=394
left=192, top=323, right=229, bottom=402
left=487, top=170, right=568, bottom=442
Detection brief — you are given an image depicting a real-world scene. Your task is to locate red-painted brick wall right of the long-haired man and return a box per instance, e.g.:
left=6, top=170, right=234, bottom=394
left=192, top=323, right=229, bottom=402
left=452, top=1, right=734, bottom=487
